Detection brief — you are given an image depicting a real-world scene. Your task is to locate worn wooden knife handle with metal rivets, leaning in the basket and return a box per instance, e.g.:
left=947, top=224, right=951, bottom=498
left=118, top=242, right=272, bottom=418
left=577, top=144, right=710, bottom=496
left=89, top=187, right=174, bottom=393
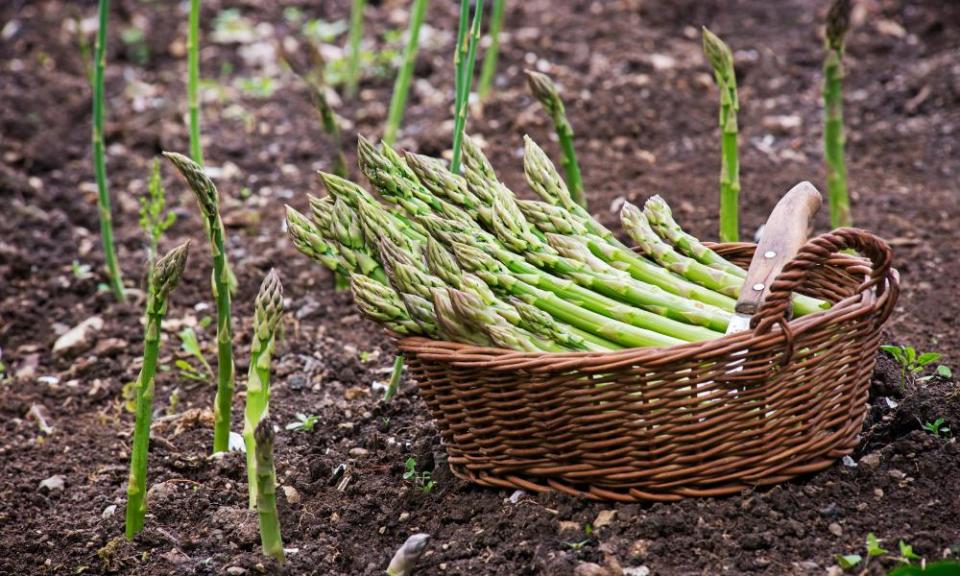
left=736, top=182, right=822, bottom=316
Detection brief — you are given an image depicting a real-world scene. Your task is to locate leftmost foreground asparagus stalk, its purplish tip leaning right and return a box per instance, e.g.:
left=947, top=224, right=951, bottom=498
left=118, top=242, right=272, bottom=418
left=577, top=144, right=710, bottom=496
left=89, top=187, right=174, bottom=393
left=125, top=242, right=190, bottom=540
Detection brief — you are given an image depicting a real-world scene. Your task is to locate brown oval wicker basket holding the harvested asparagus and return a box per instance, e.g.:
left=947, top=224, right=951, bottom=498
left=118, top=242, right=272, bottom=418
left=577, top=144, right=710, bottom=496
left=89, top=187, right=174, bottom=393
left=398, top=229, right=899, bottom=501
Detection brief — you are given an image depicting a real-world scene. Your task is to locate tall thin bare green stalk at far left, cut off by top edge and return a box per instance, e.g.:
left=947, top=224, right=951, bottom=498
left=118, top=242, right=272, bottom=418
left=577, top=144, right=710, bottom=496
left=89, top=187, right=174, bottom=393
left=92, top=0, right=127, bottom=302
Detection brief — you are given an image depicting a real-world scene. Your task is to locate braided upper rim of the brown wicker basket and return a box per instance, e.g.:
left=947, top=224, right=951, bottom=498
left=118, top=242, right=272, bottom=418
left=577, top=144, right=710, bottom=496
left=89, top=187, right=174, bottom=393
left=392, top=230, right=899, bottom=373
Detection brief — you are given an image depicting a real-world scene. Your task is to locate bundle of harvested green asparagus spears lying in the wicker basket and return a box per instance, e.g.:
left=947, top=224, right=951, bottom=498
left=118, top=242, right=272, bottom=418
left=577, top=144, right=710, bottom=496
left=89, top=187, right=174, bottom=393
left=286, top=137, right=828, bottom=352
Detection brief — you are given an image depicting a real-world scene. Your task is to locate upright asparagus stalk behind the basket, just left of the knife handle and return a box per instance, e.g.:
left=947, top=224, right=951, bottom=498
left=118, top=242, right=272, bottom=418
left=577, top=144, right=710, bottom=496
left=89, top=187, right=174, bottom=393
left=703, top=27, right=740, bottom=242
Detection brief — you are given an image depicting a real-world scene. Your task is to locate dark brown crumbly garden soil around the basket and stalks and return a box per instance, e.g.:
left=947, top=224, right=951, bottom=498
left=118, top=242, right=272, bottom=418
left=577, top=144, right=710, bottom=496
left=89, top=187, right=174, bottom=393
left=0, top=0, right=960, bottom=575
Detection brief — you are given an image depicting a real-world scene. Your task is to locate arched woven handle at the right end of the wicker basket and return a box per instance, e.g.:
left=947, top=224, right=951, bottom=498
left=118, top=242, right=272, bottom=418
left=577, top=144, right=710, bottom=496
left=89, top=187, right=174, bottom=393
left=751, top=228, right=893, bottom=333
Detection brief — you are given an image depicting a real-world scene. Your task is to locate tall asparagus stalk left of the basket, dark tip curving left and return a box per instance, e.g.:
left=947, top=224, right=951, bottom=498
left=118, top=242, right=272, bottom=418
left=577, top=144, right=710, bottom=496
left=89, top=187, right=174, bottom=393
left=163, top=152, right=234, bottom=453
